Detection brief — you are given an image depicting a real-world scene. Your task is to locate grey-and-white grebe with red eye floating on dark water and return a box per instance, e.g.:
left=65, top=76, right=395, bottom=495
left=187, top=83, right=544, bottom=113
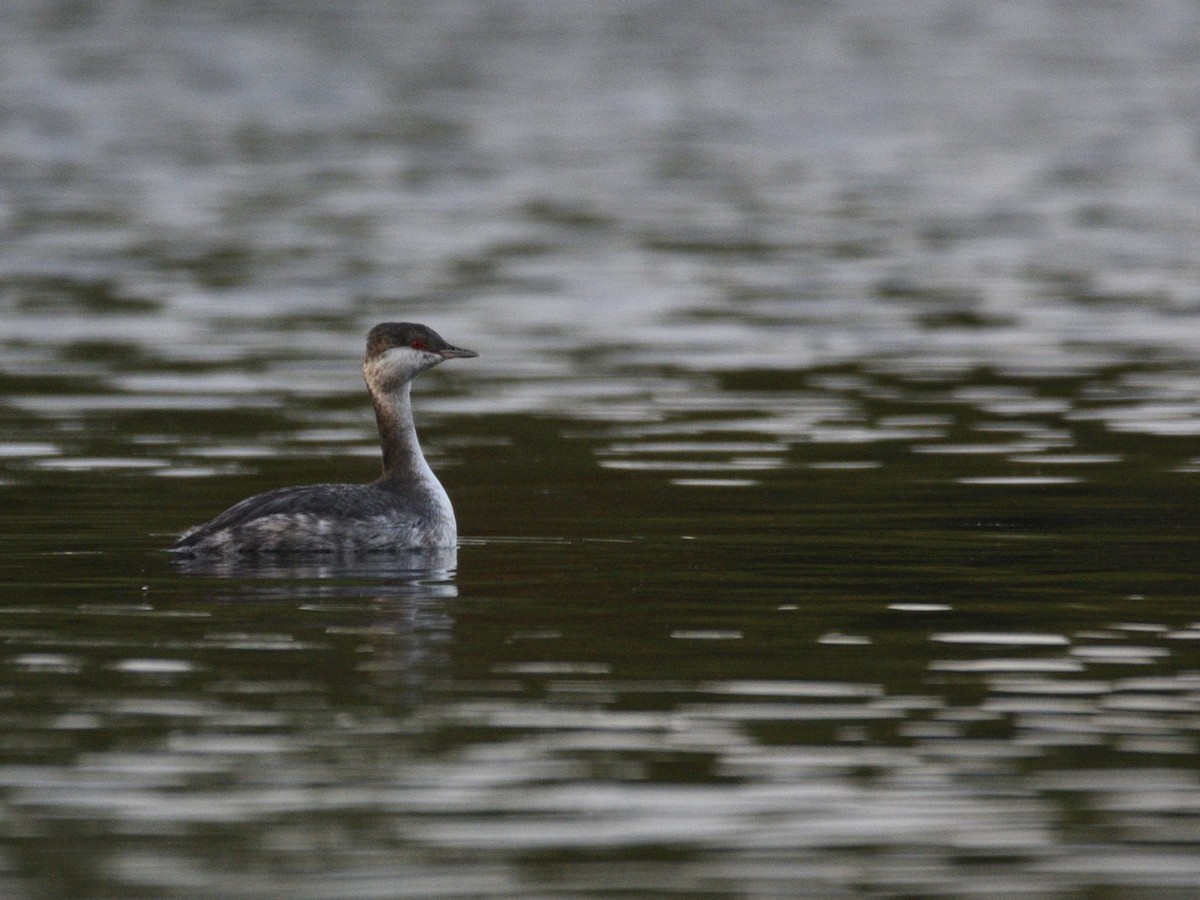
left=168, top=322, right=479, bottom=554
